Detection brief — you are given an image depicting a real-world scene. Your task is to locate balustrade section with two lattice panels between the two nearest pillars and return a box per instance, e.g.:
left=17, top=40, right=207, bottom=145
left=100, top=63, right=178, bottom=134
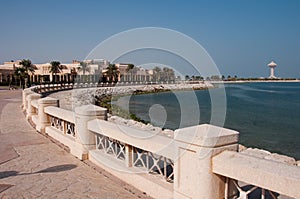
left=87, top=119, right=175, bottom=198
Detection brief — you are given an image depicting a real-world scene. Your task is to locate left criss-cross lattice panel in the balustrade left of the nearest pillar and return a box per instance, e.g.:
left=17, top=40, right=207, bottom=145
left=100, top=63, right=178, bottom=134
left=96, top=134, right=125, bottom=160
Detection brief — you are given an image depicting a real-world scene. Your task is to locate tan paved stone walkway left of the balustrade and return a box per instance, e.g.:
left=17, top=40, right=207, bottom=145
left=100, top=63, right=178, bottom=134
left=0, top=88, right=149, bottom=199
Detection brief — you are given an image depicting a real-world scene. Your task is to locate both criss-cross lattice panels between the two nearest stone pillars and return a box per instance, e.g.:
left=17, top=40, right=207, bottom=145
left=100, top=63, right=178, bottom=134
left=96, top=134, right=174, bottom=183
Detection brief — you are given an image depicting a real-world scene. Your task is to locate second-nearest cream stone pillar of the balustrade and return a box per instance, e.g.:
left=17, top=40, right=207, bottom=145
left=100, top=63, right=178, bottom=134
left=75, top=105, right=107, bottom=159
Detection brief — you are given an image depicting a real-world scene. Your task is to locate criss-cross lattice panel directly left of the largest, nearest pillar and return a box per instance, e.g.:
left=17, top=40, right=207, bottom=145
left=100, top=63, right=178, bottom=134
left=133, top=147, right=174, bottom=182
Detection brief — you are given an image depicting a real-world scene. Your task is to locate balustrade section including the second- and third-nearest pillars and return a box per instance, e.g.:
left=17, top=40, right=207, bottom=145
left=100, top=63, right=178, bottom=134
left=36, top=102, right=107, bottom=160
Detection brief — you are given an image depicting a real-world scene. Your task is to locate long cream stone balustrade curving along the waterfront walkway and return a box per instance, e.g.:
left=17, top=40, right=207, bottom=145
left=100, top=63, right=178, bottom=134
left=23, top=85, right=300, bottom=199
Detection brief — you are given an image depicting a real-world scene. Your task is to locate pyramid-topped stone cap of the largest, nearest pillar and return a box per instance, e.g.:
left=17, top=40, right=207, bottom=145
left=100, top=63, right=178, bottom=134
left=174, top=124, right=239, bottom=147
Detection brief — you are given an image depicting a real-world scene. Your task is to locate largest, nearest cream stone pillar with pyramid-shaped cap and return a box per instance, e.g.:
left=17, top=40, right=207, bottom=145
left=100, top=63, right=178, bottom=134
left=174, top=124, right=239, bottom=199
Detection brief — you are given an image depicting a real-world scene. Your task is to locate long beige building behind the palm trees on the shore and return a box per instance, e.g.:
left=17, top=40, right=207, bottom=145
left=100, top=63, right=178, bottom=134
left=0, top=59, right=175, bottom=84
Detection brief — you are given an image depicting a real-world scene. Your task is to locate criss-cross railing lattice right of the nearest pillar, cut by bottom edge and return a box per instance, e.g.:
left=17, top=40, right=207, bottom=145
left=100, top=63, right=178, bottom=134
left=225, top=177, right=279, bottom=199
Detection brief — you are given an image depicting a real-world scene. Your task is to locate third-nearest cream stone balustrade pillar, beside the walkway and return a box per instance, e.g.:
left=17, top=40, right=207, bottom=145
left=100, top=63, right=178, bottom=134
left=36, top=97, right=59, bottom=133
